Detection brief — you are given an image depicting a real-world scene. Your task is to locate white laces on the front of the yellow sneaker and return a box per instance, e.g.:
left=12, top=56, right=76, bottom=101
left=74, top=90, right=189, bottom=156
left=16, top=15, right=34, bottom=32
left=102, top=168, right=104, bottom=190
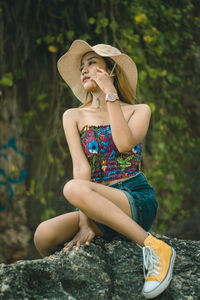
left=142, top=246, right=161, bottom=278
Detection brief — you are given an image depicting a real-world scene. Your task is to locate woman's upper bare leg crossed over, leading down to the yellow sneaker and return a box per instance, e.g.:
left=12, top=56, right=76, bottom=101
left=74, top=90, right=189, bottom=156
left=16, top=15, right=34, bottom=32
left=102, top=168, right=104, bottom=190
left=63, top=179, right=148, bottom=246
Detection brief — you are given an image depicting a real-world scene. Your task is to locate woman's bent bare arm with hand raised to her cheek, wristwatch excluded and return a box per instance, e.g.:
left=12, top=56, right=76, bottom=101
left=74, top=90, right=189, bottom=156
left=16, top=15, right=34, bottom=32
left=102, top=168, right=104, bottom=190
left=93, top=68, right=151, bottom=153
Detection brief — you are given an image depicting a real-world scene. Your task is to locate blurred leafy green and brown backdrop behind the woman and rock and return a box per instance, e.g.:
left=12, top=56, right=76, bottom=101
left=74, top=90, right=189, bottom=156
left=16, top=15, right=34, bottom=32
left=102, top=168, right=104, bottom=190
left=0, top=0, right=200, bottom=263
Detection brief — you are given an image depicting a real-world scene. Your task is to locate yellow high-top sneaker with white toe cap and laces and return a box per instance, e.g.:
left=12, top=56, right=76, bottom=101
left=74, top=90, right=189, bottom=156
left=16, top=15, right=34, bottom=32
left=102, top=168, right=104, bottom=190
left=142, top=234, right=176, bottom=299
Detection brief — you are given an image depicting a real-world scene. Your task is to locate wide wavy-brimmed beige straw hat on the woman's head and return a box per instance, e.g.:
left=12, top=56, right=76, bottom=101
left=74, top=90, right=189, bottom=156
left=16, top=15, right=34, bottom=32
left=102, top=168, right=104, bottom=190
left=57, top=40, right=137, bottom=103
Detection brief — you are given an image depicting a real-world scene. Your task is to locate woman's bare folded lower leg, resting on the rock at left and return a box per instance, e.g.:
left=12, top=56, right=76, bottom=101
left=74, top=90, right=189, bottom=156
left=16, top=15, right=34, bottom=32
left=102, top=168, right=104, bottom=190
left=34, top=212, right=101, bottom=257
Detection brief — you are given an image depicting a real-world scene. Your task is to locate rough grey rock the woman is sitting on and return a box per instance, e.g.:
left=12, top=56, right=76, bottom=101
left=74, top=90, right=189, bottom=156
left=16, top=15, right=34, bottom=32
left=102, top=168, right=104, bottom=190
left=0, top=237, right=200, bottom=300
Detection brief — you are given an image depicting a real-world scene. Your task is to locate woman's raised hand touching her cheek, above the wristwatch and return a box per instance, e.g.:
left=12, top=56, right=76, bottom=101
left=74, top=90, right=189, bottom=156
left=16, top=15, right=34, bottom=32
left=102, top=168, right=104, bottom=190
left=91, top=67, right=117, bottom=94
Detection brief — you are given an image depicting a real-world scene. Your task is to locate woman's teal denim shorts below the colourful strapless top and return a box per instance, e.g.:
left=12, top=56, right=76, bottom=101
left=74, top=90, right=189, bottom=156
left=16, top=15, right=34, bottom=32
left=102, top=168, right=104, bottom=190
left=95, top=172, right=158, bottom=240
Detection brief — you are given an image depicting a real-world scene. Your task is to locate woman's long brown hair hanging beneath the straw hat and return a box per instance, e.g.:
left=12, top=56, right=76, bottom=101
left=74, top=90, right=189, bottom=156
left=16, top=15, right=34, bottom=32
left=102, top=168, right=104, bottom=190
left=80, top=56, right=135, bottom=107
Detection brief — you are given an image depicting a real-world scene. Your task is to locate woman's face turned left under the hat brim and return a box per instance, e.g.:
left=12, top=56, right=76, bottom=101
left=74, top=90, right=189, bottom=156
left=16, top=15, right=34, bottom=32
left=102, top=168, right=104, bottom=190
left=80, top=52, right=106, bottom=92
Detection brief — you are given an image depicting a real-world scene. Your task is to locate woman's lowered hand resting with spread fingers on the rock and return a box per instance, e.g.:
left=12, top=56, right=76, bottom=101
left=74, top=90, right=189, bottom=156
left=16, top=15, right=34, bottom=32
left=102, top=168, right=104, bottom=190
left=64, top=226, right=95, bottom=251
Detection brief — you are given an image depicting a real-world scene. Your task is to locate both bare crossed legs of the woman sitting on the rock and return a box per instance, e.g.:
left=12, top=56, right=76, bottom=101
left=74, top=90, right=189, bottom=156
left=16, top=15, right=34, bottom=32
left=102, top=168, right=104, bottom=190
left=34, top=179, right=148, bottom=257
